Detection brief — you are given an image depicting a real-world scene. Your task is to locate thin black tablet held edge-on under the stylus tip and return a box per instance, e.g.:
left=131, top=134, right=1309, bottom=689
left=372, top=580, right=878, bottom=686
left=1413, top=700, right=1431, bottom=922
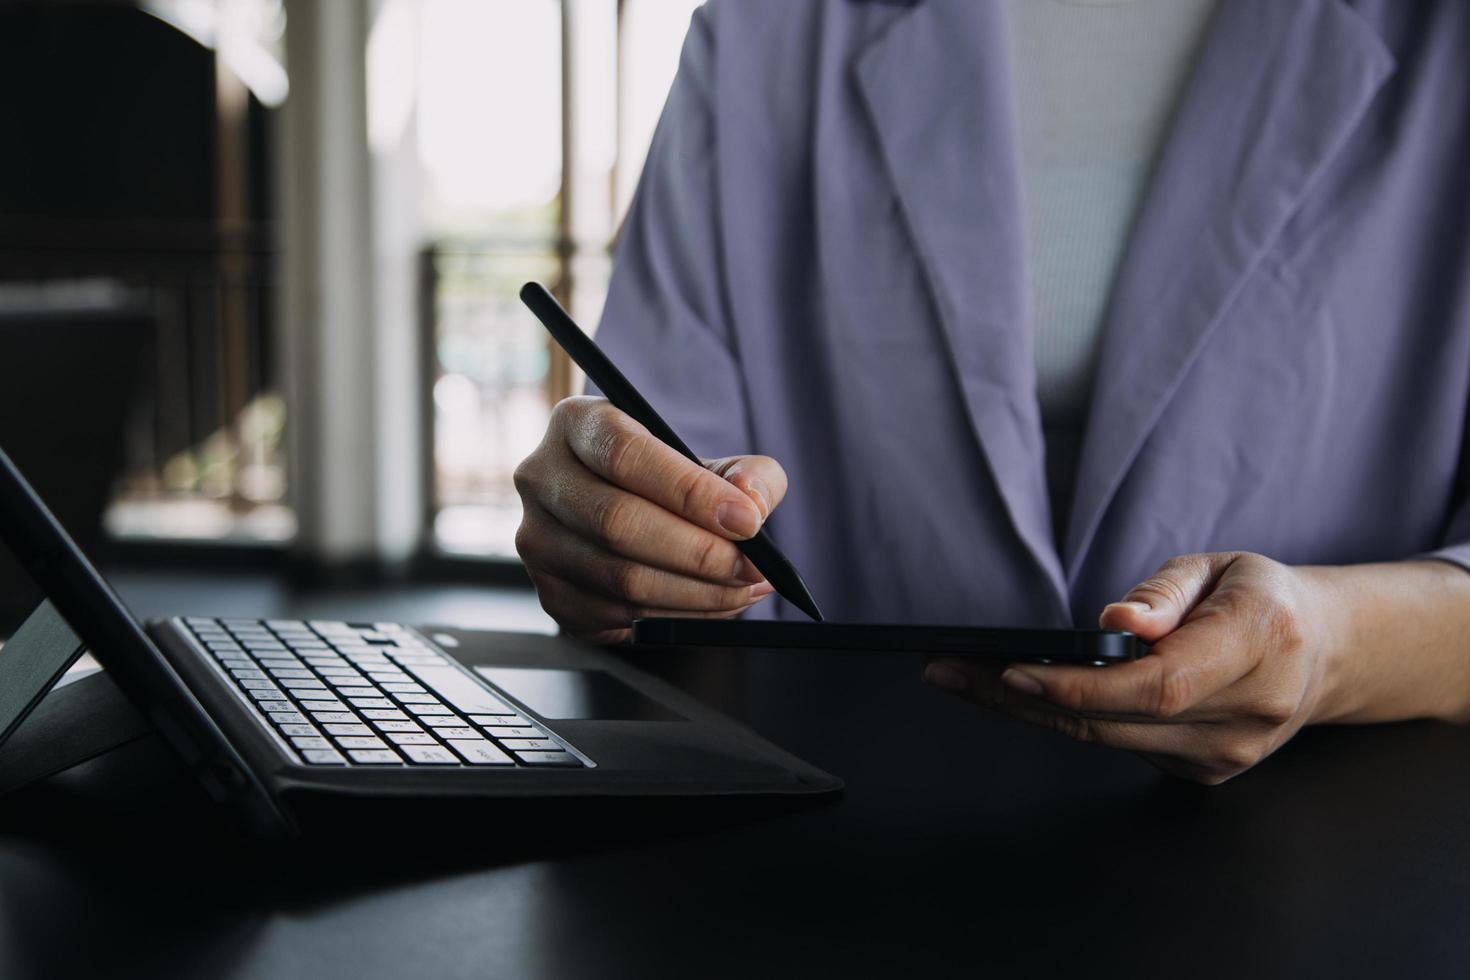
left=634, top=617, right=1144, bottom=667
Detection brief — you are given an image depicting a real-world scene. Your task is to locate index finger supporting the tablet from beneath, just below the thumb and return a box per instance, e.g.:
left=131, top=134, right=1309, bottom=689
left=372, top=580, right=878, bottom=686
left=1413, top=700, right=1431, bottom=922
left=1001, top=597, right=1260, bottom=720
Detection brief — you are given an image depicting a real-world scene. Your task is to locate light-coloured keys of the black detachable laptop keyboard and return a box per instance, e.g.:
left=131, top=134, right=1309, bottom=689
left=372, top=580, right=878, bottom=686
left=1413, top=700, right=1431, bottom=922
left=184, top=617, right=587, bottom=768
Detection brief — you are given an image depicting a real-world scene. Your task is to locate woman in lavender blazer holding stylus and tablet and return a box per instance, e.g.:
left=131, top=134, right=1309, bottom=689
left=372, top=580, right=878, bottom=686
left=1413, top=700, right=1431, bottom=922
left=517, top=0, right=1470, bottom=783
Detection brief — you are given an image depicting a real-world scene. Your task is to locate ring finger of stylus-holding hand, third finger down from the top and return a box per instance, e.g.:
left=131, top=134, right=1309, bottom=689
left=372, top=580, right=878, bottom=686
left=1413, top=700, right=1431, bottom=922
left=516, top=505, right=772, bottom=611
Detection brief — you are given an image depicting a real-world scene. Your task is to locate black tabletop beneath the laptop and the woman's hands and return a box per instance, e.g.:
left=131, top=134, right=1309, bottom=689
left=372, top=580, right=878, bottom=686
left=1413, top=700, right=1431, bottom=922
left=0, top=578, right=1470, bottom=979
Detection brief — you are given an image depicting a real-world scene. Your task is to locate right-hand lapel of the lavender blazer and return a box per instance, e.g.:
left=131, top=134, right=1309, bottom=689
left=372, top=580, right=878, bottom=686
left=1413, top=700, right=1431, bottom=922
left=1066, top=0, right=1394, bottom=577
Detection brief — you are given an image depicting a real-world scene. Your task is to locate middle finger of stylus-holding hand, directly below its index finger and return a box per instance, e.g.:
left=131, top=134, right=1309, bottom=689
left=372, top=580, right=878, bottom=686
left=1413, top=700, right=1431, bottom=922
left=522, top=458, right=764, bottom=585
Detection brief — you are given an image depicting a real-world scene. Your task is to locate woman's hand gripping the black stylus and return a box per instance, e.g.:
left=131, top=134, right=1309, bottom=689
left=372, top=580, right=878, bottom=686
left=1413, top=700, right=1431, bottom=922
left=516, top=397, right=786, bottom=644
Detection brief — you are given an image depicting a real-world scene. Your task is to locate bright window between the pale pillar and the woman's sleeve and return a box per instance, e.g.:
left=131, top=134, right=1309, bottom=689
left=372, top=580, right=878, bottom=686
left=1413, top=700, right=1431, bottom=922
left=420, top=0, right=698, bottom=555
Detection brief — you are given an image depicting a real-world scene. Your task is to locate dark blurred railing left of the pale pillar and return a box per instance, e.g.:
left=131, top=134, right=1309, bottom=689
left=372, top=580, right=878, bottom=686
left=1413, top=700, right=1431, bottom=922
left=0, top=220, right=294, bottom=541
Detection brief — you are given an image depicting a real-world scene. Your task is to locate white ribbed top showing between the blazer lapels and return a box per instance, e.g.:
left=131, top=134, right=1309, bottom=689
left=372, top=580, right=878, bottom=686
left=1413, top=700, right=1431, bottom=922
left=1005, top=0, right=1217, bottom=539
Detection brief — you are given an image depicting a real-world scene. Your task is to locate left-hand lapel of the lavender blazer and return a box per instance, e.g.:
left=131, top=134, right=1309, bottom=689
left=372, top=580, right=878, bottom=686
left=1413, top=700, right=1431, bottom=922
left=856, top=0, right=1066, bottom=608
